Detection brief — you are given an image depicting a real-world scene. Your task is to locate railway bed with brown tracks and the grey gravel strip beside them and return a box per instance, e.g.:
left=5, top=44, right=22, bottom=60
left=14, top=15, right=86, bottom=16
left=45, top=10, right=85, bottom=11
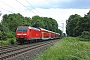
left=0, top=40, right=57, bottom=60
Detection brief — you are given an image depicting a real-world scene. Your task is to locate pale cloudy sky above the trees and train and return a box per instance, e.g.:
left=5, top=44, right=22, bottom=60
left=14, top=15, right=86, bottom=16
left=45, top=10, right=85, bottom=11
left=0, top=0, right=90, bottom=32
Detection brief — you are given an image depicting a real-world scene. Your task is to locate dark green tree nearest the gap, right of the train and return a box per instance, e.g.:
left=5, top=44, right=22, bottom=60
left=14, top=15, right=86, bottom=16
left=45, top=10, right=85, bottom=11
left=66, top=14, right=81, bottom=36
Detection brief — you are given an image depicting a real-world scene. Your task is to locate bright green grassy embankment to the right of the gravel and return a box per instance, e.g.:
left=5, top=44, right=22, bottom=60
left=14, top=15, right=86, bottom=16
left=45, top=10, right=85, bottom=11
left=34, top=37, right=90, bottom=60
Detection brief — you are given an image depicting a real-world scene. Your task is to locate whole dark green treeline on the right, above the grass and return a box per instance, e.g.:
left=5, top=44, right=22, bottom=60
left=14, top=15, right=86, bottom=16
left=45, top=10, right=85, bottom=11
left=66, top=11, right=90, bottom=39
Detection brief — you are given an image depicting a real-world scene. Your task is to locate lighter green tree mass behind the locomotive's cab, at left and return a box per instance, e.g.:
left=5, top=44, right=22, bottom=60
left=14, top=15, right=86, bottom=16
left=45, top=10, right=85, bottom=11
left=2, top=13, right=31, bottom=32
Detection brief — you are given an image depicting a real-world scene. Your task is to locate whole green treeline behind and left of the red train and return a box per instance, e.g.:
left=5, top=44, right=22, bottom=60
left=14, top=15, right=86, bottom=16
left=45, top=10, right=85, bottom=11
left=0, top=13, right=62, bottom=40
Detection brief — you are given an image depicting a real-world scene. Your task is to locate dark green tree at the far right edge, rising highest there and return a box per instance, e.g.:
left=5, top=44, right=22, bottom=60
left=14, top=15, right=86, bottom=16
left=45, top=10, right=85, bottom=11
left=76, top=11, right=90, bottom=36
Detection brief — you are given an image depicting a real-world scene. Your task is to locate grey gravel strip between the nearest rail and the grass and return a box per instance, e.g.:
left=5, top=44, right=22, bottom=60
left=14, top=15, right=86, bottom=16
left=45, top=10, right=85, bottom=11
left=10, top=42, right=51, bottom=60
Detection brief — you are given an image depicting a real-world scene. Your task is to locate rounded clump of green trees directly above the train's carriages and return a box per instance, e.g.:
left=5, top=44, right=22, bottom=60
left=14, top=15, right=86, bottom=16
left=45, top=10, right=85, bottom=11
left=32, top=16, right=58, bottom=32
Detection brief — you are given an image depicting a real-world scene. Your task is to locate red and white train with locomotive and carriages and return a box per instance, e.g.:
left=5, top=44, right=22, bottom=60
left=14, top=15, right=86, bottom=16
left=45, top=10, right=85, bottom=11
left=16, top=26, right=60, bottom=43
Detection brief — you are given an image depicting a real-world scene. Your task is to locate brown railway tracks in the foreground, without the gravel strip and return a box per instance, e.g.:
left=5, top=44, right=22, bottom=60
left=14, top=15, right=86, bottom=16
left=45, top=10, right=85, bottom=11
left=0, top=40, right=57, bottom=60
